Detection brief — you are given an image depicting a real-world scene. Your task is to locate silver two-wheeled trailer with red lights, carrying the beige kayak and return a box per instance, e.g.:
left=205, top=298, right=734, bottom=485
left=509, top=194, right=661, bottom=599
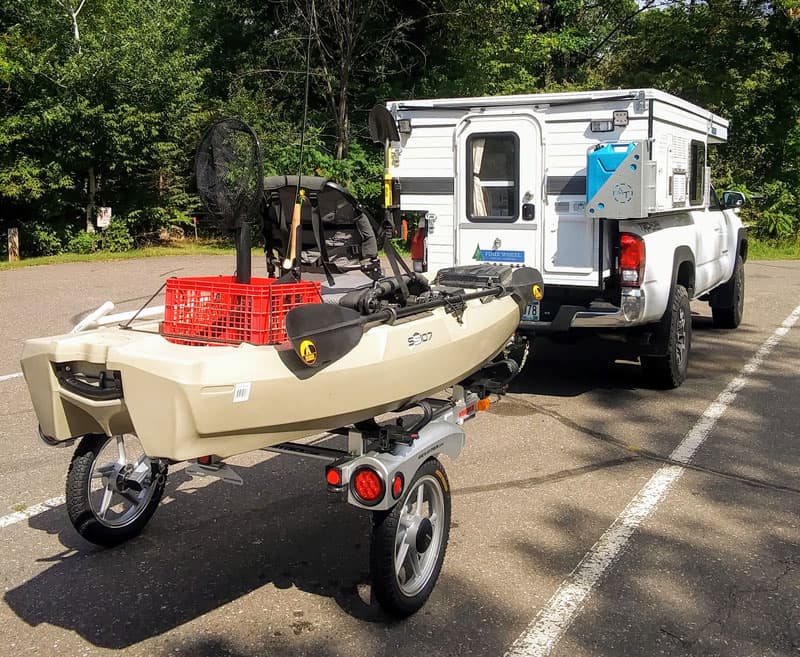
left=47, top=303, right=500, bottom=618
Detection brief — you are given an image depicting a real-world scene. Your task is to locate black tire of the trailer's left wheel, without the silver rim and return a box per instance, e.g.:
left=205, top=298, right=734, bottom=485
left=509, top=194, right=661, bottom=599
left=66, top=434, right=167, bottom=547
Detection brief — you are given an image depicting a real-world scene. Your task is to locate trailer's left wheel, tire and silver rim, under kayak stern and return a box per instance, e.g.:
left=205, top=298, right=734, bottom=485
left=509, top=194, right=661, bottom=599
left=66, top=434, right=167, bottom=546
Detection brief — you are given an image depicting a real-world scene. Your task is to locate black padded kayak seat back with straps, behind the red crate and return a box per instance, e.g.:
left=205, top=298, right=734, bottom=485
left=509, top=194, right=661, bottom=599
left=261, top=176, right=383, bottom=280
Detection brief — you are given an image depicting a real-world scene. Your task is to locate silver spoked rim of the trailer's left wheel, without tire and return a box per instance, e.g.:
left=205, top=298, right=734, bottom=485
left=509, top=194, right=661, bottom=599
left=88, top=434, right=156, bottom=528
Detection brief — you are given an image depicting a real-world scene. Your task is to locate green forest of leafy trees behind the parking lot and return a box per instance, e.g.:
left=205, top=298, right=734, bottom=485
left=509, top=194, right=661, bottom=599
left=0, top=0, right=800, bottom=256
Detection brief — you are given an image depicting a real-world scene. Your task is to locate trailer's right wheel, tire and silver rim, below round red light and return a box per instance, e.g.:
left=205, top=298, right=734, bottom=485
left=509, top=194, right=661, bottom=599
left=370, top=458, right=450, bottom=618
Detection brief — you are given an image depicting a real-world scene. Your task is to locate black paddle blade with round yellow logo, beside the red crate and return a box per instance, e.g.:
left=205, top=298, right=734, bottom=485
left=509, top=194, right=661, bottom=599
left=286, top=303, right=364, bottom=367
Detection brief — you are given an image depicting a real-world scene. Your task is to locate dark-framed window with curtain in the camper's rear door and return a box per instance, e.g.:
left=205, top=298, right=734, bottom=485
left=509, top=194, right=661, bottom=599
left=467, top=132, right=519, bottom=223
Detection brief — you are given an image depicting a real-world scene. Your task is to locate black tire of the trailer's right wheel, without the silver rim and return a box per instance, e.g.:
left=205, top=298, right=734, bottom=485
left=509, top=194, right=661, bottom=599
left=370, top=458, right=450, bottom=618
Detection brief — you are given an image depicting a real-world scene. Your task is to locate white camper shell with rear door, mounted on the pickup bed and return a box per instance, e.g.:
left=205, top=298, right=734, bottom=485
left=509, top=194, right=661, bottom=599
left=388, top=89, right=728, bottom=287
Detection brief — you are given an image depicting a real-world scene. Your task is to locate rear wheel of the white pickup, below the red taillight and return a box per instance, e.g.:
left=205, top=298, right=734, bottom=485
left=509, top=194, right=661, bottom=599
left=639, top=285, right=692, bottom=390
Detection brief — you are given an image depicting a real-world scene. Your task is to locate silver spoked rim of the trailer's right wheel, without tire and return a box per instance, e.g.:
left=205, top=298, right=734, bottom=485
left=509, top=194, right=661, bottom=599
left=394, top=475, right=446, bottom=597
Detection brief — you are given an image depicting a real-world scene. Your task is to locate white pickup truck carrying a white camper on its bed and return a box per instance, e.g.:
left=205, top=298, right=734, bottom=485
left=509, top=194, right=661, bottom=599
left=388, top=89, right=747, bottom=388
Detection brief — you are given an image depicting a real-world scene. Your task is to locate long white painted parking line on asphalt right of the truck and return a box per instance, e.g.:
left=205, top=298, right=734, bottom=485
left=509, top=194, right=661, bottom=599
left=506, top=306, right=800, bottom=657
